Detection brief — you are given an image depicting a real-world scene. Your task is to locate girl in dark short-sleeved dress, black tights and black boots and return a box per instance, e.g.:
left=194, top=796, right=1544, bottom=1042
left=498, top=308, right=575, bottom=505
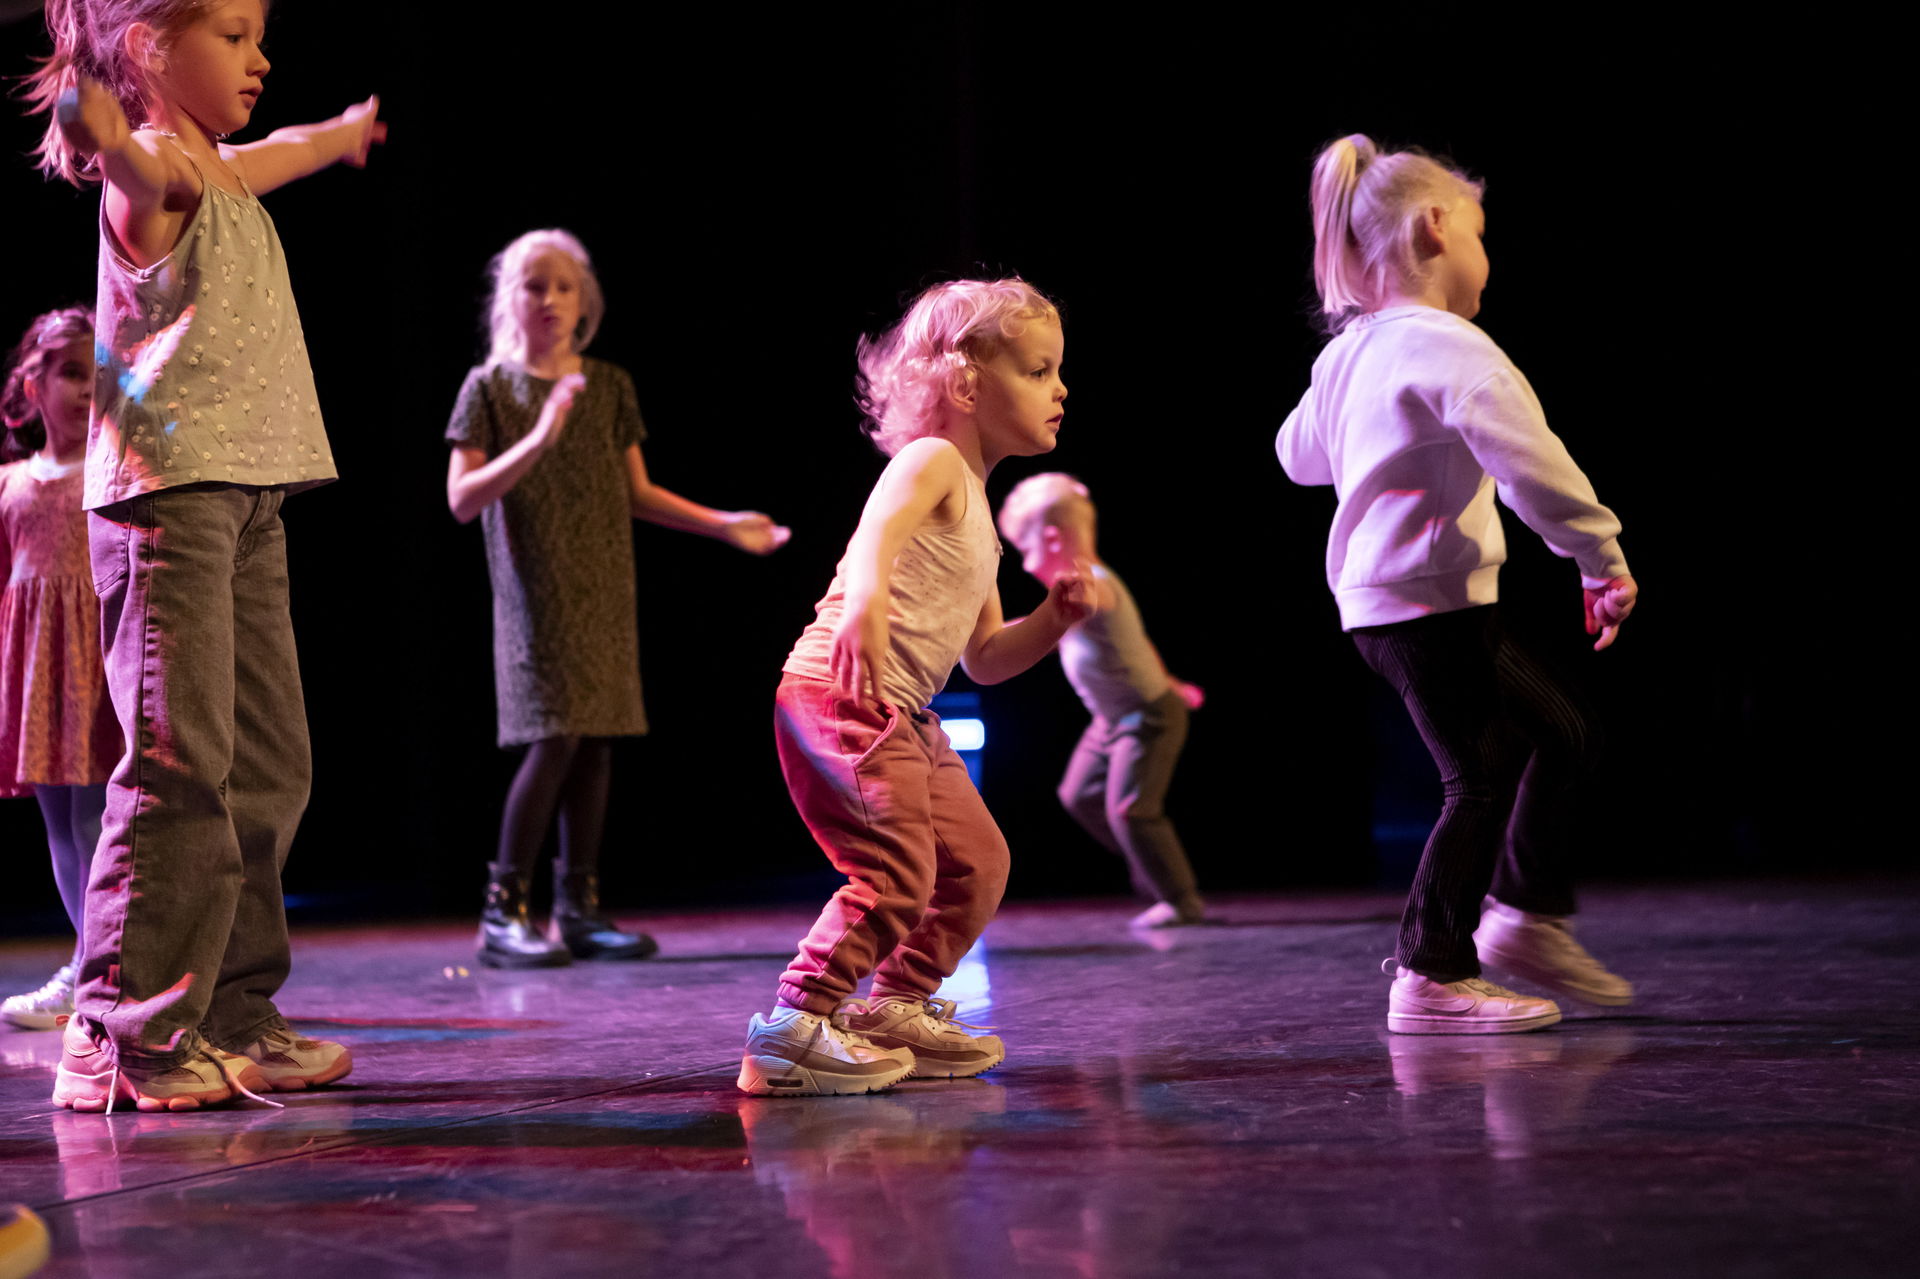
left=447, top=230, right=787, bottom=968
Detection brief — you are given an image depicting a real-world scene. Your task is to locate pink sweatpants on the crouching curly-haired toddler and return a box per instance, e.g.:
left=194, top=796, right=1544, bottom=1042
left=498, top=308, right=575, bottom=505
left=774, top=674, right=1008, bottom=1012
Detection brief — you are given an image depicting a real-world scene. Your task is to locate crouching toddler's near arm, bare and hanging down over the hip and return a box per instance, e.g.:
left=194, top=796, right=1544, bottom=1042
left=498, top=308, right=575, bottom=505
left=828, top=438, right=966, bottom=703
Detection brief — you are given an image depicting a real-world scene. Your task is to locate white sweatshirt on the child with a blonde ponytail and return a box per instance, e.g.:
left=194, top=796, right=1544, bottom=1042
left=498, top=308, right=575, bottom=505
left=1275, top=305, right=1626, bottom=630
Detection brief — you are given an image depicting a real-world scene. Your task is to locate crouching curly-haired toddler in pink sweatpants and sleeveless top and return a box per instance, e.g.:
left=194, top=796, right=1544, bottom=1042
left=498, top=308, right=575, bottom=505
left=739, top=278, right=1092, bottom=1097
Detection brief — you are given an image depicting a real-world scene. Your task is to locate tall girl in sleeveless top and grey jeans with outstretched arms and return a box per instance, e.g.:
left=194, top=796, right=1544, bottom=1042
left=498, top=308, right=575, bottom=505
left=29, top=0, right=384, bottom=1110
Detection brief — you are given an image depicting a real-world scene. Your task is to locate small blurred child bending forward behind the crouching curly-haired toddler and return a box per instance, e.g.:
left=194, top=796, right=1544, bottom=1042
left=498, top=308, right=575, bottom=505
left=1000, top=472, right=1206, bottom=928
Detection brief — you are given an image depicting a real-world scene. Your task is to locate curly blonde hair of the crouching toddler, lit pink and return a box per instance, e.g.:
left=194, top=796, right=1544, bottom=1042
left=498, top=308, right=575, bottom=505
left=856, top=277, right=1060, bottom=457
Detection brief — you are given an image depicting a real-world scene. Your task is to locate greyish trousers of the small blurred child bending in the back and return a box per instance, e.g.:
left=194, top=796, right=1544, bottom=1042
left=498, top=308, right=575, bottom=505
left=1060, top=691, right=1200, bottom=912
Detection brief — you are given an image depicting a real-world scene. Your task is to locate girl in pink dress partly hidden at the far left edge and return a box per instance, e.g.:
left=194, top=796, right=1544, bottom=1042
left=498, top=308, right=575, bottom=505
left=0, top=307, right=121, bottom=1029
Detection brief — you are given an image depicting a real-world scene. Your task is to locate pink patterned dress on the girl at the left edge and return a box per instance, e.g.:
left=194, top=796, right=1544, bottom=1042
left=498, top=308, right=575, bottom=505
left=0, top=459, right=121, bottom=795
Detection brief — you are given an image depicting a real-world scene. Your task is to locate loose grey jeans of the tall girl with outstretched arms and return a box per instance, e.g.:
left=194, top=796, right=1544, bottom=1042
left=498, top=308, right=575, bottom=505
left=75, top=484, right=311, bottom=1064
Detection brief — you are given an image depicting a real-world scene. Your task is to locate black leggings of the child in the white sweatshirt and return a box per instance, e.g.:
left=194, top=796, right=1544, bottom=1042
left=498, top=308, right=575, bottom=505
left=1354, top=605, right=1599, bottom=981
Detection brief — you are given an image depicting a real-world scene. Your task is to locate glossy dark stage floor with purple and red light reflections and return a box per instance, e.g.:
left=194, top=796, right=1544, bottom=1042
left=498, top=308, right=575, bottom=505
left=0, top=880, right=1920, bottom=1279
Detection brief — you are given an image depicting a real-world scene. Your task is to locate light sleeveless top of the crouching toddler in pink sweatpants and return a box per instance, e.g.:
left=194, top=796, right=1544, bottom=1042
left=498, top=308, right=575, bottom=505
left=781, top=453, right=1000, bottom=711
